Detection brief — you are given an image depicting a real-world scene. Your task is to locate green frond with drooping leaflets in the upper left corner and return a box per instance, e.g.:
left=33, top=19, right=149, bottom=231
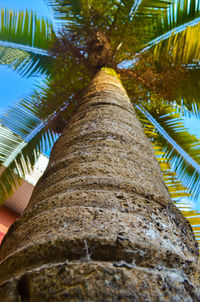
left=0, top=9, right=54, bottom=76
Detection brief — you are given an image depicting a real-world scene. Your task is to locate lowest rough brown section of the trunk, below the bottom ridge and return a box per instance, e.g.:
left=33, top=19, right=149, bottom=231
left=0, top=260, right=200, bottom=302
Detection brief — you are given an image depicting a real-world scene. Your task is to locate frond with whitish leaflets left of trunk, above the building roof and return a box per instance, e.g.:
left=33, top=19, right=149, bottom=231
left=0, top=98, right=57, bottom=202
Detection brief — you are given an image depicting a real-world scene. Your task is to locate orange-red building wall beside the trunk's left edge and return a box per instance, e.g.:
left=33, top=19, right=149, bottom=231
left=0, top=206, right=19, bottom=244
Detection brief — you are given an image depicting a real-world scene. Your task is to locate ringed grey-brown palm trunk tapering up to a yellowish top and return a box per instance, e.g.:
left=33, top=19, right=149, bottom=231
left=0, top=71, right=200, bottom=302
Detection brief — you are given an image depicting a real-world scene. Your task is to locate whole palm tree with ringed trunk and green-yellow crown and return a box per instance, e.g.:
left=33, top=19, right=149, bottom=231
left=0, top=1, right=200, bottom=301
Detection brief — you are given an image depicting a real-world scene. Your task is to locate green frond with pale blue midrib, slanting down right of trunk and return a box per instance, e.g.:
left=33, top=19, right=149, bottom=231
left=137, top=106, right=200, bottom=198
